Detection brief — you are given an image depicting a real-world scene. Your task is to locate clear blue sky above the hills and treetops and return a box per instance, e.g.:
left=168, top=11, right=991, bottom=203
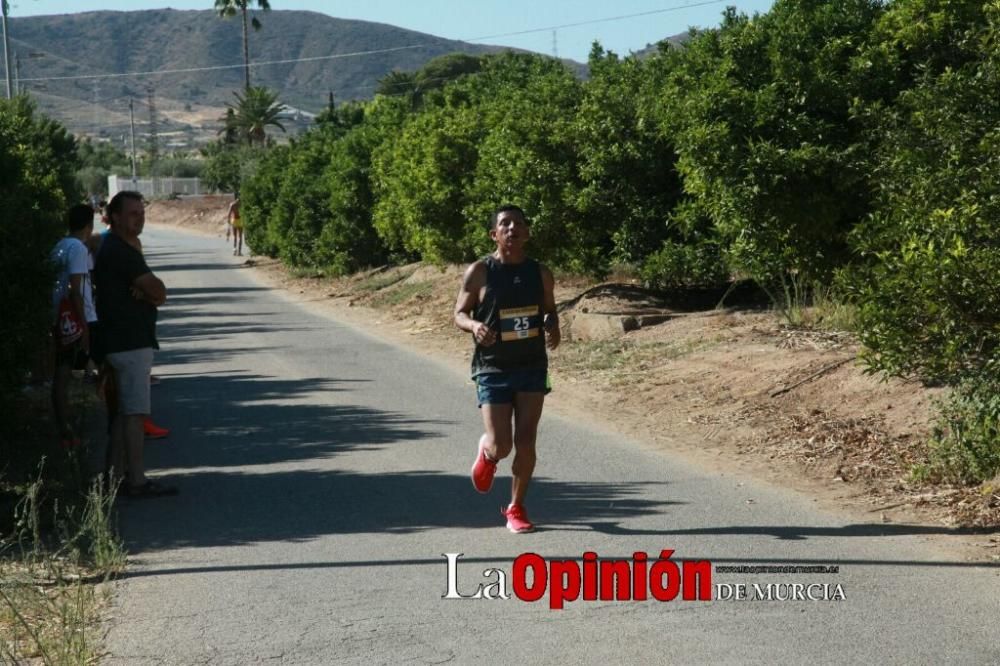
left=8, top=0, right=773, bottom=62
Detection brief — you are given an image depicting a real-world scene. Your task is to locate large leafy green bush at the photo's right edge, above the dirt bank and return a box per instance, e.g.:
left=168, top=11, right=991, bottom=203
left=853, top=3, right=1000, bottom=382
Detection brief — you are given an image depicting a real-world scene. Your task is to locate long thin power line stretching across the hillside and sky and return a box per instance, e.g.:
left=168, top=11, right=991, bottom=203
left=23, top=0, right=727, bottom=81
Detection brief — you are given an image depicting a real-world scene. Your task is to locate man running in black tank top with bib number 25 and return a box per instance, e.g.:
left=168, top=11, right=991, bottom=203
left=455, top=204, right=560, bottom=533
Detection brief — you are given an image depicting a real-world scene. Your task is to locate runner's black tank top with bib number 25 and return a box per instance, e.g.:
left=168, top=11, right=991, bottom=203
left=472, top=255, right=549, bottom=377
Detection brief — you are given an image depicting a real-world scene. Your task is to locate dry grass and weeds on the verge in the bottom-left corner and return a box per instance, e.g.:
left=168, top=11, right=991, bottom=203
left=0, top=387, right=125, bottom=666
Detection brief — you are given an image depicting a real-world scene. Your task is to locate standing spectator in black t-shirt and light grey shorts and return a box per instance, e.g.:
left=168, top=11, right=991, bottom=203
left=94, top=191, right=177, bottom=497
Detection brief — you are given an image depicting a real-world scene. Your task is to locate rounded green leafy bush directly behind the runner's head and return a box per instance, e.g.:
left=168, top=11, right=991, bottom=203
left=373, top=54, right=589, bottom=263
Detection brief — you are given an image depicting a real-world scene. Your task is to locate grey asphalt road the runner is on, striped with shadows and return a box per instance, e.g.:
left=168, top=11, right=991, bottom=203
left=105, top=228, right=1000, bottom=665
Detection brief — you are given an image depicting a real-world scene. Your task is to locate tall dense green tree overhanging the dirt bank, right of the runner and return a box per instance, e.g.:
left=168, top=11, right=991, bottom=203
left=658, top=0, right=882, bottom=282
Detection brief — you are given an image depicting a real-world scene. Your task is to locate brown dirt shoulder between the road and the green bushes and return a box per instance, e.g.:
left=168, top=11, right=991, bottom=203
left=147, top=200, right=1000, bottom=559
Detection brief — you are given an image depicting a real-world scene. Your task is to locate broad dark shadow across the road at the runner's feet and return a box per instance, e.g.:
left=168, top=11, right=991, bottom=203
left=119, top=468, right=672, bottom=553
